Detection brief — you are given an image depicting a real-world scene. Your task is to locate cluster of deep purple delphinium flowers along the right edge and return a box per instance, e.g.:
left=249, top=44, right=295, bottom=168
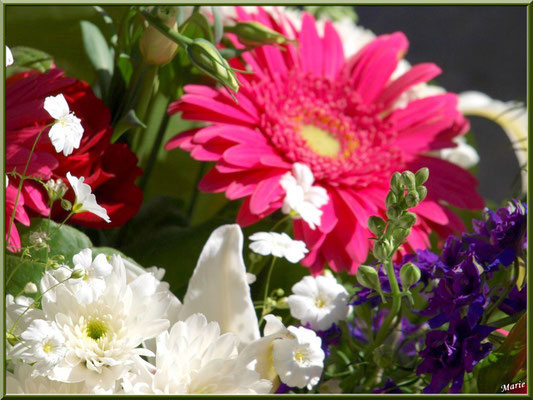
left=417, top=201, right=527, bottom=393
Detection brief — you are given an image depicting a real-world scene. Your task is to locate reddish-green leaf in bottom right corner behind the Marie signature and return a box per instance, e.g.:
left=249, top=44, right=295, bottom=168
left=477, top=313, right=527, bottom=393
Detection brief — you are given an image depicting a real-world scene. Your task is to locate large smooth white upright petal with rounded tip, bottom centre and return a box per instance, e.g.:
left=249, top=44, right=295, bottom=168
left=179, top=225, right=259, bottom=344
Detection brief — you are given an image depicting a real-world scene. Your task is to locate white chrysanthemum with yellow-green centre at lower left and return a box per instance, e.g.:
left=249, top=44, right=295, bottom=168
left=41, top=256, right=173, bottom=391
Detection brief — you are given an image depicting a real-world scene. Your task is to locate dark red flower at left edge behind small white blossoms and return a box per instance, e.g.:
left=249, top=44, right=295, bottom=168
left=6, top=69, right=142, bottom=247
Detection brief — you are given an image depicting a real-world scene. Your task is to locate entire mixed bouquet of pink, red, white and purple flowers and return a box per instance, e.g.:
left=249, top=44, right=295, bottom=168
left=4, top=5, right=527, bottom=394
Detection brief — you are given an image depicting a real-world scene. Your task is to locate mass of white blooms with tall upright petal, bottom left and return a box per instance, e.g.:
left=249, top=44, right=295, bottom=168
left=6, top=225, right=324, bottom=394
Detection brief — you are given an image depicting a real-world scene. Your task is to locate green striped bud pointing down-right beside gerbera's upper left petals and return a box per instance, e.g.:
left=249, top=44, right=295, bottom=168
left=187, top=39, right=239, bottom=92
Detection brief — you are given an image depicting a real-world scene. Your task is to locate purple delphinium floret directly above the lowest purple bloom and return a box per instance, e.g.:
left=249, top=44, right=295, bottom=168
left=422, top=254, right=489, bottom=328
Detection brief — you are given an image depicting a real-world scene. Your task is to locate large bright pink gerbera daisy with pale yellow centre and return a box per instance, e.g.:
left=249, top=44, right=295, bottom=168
left=167, top=8, right=483, bottom=274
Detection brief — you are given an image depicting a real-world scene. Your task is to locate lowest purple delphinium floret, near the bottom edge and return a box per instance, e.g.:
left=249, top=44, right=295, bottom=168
left=417, top=313, right=495, bottom=393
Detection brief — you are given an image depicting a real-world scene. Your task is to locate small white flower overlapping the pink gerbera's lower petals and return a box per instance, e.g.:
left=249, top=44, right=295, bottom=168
left=279, top=163, right=329, bottom=229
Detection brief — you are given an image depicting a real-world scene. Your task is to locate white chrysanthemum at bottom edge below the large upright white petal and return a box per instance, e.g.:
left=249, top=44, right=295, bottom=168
left=123, top=314, right=271, bottom=394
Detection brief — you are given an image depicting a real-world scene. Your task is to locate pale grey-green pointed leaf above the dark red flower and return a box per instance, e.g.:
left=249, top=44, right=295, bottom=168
left=80, top=20, right=114, bottom=98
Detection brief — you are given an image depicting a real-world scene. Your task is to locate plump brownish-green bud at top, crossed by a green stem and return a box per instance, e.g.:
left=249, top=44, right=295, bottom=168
left=139, top=7, right=178, bottom=65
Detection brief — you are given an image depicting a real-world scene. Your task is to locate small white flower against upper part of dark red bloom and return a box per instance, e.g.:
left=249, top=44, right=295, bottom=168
left=44, top=94, right=83, bottom=156
